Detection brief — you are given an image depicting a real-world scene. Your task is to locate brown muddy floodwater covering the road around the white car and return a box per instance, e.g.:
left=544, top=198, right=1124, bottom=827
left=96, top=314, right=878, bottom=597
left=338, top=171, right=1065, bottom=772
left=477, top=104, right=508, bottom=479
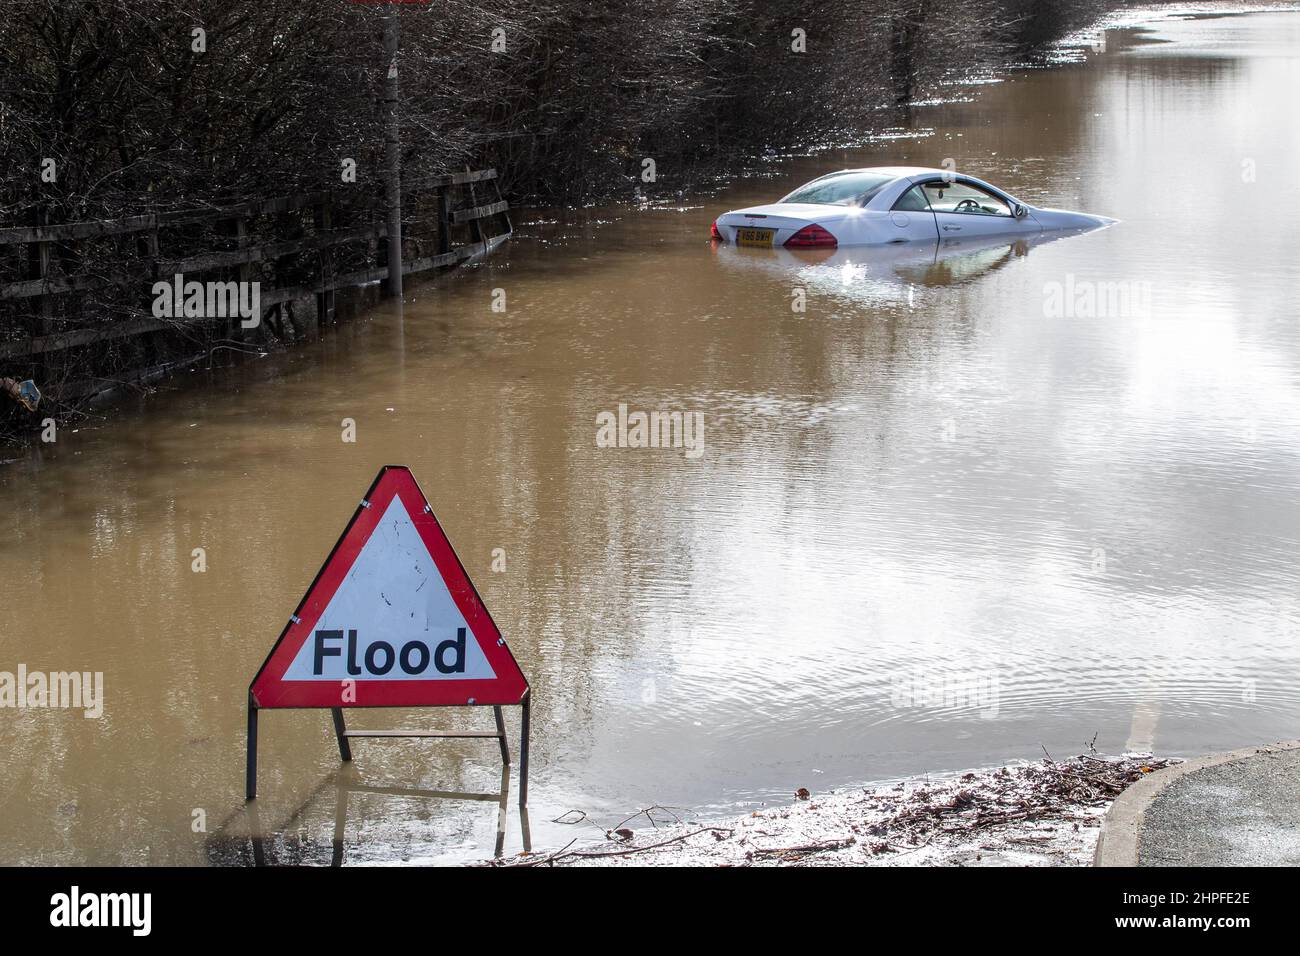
left=0, top=7, right=1300, bottom=864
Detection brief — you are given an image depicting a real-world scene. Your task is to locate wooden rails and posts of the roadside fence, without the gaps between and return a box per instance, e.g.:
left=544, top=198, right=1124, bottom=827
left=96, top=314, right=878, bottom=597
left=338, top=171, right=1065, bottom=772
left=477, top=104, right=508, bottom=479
left=0, top=169, right=512, bottom=359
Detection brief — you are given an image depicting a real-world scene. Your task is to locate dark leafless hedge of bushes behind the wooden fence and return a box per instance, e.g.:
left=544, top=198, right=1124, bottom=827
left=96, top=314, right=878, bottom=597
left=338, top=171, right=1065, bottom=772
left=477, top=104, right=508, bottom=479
left=0, top=0, right=1117, bottom=213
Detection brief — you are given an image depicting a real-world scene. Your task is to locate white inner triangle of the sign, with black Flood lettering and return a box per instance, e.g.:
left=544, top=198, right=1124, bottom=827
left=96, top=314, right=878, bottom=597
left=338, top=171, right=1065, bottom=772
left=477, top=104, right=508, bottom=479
left=282, top=496, right=497, bottom=683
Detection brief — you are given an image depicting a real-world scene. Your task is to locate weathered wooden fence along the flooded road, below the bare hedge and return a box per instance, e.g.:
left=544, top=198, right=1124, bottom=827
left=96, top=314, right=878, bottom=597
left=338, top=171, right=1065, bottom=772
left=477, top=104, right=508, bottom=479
left=0, top=169, right=511, bottom=364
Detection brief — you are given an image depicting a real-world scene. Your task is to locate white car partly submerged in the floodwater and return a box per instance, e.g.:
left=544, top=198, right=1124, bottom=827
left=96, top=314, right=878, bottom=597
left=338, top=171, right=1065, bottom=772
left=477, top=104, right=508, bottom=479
left=710, top=166, right=1115, bottom=248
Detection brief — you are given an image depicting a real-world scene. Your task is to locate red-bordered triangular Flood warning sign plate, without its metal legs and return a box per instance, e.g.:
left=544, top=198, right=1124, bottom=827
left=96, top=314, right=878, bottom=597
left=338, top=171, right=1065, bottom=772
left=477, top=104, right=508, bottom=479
left=248, top=464, right=528, bottom=708
